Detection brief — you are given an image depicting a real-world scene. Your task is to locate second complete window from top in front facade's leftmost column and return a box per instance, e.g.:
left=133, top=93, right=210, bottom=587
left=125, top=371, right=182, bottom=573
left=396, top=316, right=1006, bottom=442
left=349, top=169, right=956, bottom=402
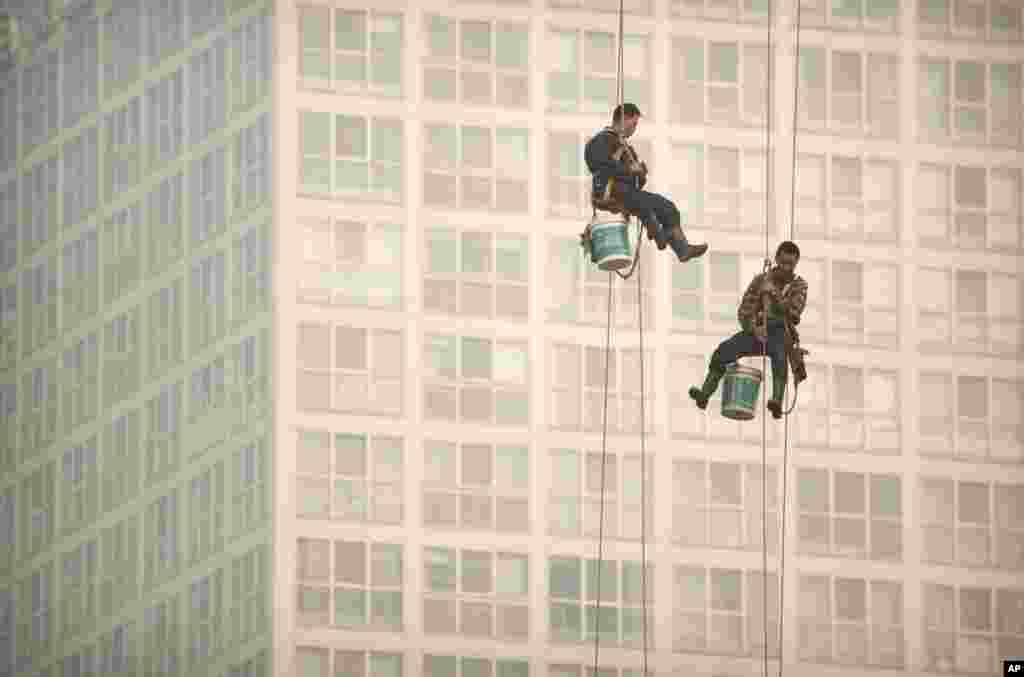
left=299, top=111, right=404, bottom=203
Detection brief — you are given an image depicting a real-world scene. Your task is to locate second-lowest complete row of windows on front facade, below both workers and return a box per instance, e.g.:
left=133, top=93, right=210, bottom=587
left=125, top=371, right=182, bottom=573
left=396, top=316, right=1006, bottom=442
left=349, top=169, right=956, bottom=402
left=296, top=430, right=1024, bottom=569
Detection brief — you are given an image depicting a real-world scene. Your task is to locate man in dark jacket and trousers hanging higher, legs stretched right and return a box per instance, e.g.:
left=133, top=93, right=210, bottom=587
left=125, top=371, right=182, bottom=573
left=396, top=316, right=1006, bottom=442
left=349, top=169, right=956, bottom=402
left=584, top=103, right=708, bottom=262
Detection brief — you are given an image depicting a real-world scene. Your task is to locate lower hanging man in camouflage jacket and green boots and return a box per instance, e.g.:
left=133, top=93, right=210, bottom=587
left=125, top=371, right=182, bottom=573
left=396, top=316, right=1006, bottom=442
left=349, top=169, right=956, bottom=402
left=690, top=242, right=807, bottom=419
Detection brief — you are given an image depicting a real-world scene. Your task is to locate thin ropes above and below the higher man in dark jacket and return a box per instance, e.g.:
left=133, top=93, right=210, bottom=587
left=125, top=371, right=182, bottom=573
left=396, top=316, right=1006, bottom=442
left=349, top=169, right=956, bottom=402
left=592, top=0, right=648, bottom=677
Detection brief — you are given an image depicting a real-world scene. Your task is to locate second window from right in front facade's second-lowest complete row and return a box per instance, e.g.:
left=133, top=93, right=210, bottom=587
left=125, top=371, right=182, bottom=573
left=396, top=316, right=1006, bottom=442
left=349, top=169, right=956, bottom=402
left=797, top=468, right=903, bottom=561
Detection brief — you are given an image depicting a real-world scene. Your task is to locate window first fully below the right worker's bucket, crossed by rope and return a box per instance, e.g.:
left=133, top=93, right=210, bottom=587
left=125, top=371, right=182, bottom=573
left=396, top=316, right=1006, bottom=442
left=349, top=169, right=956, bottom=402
left=672, top=459, right=779, bottom=553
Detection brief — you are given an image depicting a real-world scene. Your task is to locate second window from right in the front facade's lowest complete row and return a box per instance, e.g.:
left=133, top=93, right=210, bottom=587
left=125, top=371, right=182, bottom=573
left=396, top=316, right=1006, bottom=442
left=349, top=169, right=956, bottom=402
left=798, top=575, right=906, bottom=670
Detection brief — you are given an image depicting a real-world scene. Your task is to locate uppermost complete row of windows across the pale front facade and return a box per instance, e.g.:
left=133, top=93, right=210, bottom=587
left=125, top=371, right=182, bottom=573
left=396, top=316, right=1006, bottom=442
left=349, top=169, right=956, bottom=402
left=298, top=7, right=1021, bottom=146
